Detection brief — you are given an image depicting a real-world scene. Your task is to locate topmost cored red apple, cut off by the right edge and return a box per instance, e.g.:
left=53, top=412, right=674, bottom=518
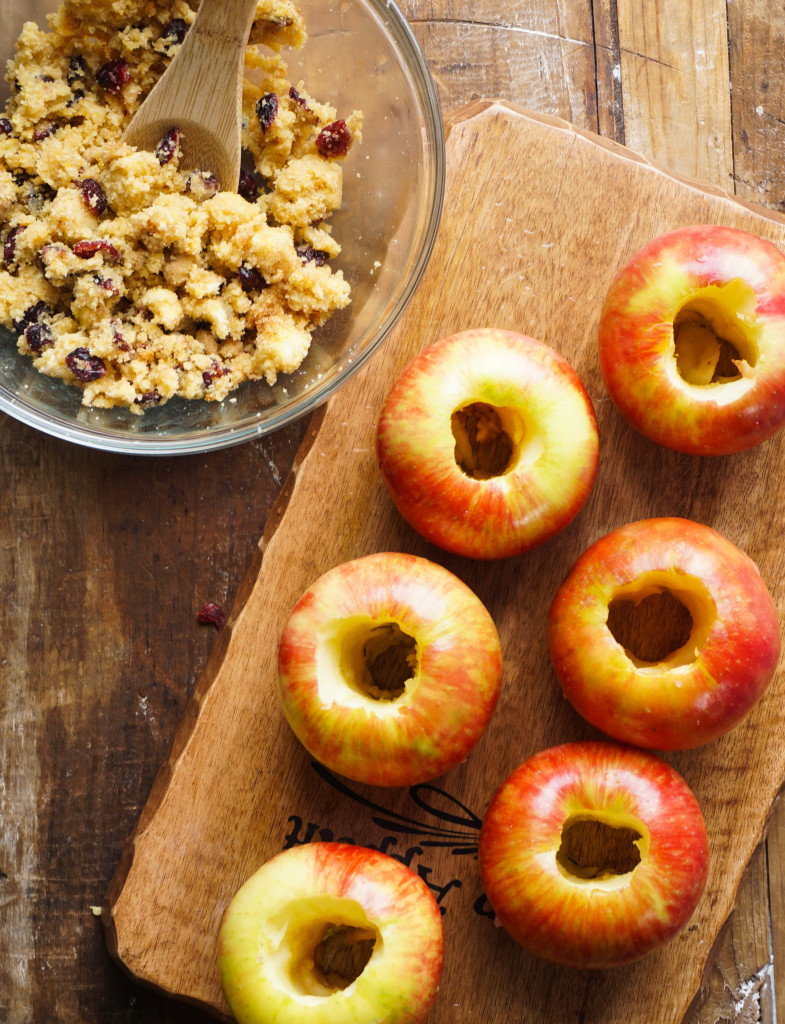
left=599, top=225, right=785, bottom=456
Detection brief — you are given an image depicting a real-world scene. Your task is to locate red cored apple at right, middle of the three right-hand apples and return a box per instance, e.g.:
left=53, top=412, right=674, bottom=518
left=548, top=517, right=780, bottom=751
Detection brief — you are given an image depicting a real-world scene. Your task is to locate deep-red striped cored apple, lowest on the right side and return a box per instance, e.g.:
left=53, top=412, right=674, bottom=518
left=479, top=740, right=709, bottom=969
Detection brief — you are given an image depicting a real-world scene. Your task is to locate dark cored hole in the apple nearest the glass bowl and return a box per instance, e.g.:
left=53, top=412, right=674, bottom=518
left=450, top=401, right=523, bottom=480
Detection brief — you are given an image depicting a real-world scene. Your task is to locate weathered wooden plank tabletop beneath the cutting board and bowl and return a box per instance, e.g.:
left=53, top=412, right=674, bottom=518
left=0, top=0, right=785, bottom=1024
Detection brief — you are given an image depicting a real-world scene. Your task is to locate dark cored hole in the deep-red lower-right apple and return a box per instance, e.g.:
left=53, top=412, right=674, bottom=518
left=556, top=817, right=643, bottom=881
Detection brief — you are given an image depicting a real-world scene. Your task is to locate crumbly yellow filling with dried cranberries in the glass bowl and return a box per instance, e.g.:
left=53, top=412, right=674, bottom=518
left=0, top=0, right=360, bottom=413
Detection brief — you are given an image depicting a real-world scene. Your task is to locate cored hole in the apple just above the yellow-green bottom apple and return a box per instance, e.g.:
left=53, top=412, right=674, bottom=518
left=342, top=622, right=418, bottom=700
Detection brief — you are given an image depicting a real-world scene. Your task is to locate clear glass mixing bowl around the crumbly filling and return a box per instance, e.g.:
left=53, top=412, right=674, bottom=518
left=0, top=0, right=444, bottom=455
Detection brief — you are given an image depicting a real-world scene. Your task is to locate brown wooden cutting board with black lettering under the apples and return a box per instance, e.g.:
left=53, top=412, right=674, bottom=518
left=102, top=102, right=785, bottom=1024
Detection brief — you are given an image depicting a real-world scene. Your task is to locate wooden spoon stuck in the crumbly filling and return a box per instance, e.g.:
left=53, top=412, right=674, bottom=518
left=125, top=0, right=257, bottom=191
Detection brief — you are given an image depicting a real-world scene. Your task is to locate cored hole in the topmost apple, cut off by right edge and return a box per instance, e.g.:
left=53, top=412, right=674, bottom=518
left=673, top=281, right=758, bottom=387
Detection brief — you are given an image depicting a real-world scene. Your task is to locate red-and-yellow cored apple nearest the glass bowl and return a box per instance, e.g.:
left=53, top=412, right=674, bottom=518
left=376, top=329, right=599, bottom=559
